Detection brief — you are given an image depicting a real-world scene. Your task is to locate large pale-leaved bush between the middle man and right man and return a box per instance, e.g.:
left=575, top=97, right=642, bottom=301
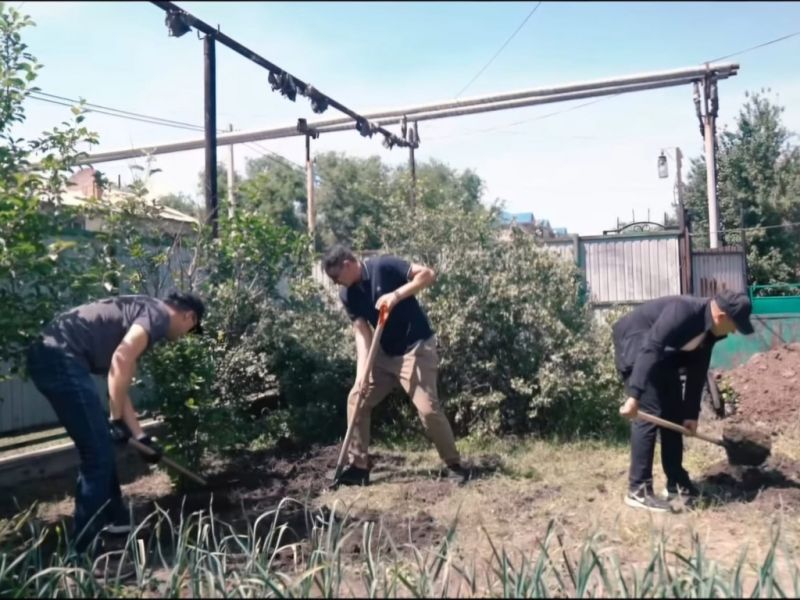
left=384, top=201, right=620, bottom=435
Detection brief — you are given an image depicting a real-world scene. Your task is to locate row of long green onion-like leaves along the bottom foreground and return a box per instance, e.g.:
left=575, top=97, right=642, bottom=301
left=0, top=499, right=800, bottom=598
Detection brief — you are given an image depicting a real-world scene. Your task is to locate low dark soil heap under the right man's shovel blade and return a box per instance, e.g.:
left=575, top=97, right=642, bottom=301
left=698, top=455, right=800, bottom=507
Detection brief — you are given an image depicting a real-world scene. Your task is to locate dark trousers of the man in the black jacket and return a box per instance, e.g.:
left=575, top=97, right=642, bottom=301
left=623, top=363, right=689, bottom=492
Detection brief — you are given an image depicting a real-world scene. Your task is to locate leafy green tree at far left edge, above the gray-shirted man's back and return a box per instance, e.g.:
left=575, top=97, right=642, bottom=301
left=0, top=5, right=103, bottom=372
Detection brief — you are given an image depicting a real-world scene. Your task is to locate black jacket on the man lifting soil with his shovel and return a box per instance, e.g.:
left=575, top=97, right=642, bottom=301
left=613, top=296, right=722, bottom=419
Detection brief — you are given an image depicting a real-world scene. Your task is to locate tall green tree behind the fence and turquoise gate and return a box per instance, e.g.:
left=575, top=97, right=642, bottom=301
left=686, top=90, right=800, bottom=284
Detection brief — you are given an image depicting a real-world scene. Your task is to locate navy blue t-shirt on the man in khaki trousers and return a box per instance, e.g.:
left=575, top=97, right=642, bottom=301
left=339, top=255, right=433, bottom=356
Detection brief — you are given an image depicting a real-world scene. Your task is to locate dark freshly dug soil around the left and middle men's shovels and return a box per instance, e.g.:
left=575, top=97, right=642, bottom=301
left=0, top=446, right=497, bottom=561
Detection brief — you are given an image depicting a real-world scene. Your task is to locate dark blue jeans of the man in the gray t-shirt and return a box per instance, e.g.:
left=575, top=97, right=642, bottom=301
left=28, top=342, right=125, bottom=552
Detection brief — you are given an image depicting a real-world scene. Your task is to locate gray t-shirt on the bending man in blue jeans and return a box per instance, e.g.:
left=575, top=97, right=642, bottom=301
left=42, top=296, right=169, bottom=375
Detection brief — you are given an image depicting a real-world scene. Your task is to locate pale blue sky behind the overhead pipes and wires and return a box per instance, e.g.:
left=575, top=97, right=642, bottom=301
left=10, top=2, right=800, bottom=234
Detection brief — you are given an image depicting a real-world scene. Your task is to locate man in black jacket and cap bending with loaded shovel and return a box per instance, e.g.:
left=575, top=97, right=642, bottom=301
left=613, top=290, right=753, bottom=512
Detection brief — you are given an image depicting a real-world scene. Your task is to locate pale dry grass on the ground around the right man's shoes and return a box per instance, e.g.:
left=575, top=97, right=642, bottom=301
left=317, top=422, right=800, bottom=580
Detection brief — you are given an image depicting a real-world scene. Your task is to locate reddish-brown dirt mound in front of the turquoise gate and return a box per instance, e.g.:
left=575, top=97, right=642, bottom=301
left=722, top=344, right=800, bottom=433
